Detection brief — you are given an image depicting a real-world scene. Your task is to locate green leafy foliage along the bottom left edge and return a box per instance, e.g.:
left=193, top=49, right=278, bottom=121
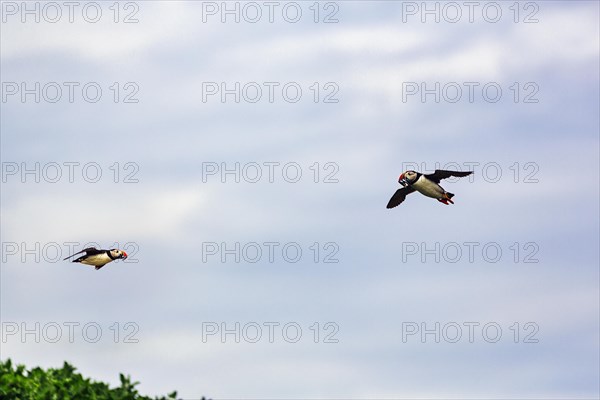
left=0, top=359, right=177, bottom=400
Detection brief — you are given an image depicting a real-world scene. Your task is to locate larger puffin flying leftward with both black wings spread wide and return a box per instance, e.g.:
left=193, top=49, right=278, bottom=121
left=387, top=169, right=473, bottom=208
